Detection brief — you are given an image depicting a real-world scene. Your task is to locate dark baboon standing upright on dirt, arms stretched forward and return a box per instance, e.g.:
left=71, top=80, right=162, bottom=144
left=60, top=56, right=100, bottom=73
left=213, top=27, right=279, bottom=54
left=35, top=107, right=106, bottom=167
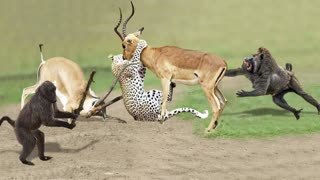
left=0, top=81, right=77, bottom=165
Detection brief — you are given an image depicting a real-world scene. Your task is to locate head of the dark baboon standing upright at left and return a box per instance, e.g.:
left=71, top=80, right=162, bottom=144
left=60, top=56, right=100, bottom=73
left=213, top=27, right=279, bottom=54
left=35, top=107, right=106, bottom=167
left=38, top=81, right=57, bottom=103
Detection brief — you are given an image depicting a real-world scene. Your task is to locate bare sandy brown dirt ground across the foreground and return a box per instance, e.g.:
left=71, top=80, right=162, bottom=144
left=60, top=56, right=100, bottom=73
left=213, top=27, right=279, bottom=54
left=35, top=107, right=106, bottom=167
left=0, top=87, right=320, bottom=180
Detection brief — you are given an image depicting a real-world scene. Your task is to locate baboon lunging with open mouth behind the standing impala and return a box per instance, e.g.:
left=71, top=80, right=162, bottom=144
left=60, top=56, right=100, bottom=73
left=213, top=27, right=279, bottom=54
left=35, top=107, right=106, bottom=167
left=225, top=47, right=320, bottom=120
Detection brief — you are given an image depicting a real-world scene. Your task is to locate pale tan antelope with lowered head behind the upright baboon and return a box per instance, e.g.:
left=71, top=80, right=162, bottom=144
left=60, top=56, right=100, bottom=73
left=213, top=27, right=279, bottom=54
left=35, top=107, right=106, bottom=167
left=21, top=44, right=106, bottom=122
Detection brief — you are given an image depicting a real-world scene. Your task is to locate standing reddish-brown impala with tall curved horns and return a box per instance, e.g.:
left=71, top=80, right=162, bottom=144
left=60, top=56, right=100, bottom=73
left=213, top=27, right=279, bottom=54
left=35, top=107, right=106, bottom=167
left=114, top=2, right=227, bottom=131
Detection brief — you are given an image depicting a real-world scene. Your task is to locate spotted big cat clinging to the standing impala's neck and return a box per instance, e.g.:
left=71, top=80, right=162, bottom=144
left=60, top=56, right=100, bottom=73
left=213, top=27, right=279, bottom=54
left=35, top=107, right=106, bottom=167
left=110, top=40, right=208, bottom=122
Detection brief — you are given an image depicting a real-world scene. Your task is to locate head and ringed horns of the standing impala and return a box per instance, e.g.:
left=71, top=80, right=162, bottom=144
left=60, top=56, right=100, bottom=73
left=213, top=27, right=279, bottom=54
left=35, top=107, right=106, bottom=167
left=114, top=1, right=144, bottom=60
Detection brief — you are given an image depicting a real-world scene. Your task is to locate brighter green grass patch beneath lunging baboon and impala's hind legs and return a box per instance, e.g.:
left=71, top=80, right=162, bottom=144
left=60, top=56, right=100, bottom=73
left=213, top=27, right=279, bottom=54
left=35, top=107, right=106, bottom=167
left=177, top=85, right=320, bottom=138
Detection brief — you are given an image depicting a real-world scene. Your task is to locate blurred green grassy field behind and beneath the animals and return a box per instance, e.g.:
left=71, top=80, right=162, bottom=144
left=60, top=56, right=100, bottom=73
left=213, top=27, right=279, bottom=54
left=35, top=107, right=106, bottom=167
left=0, top=0, right=320, bottom=137
